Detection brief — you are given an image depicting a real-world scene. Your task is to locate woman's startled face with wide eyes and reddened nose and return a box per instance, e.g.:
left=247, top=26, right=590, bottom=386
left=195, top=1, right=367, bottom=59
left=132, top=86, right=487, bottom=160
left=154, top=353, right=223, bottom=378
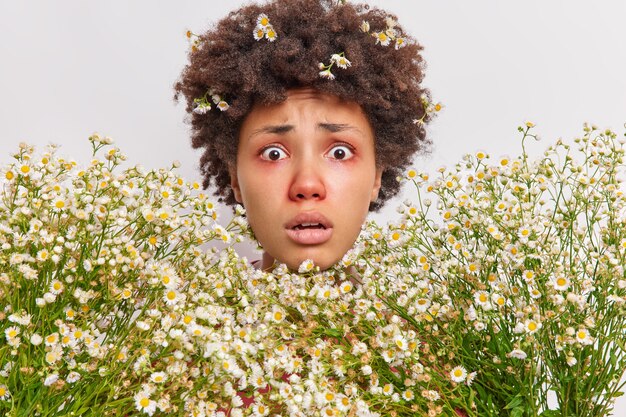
left=231, top=89, right=381, bottom=269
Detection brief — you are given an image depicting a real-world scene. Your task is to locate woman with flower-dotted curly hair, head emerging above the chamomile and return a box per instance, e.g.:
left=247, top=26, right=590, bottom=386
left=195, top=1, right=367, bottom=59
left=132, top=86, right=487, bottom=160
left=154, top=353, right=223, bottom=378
left=176, top=0, right=429, bottom=269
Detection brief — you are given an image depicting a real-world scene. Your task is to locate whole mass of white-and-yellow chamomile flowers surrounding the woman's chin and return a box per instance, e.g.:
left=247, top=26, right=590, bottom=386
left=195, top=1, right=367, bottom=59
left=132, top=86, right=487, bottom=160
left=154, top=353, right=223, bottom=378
left=0, top=124, right=626, bottom=416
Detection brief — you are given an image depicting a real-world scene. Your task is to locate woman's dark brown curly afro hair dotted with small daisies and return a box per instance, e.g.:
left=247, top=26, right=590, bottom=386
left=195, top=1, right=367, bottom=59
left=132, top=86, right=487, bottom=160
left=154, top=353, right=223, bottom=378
left=175, top=0, right=429, bottom=210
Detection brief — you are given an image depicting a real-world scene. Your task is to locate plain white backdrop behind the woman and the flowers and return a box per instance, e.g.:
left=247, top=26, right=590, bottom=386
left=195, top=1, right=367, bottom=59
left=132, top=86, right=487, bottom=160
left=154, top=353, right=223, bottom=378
left=0, top=0, right=626, bottom=417
